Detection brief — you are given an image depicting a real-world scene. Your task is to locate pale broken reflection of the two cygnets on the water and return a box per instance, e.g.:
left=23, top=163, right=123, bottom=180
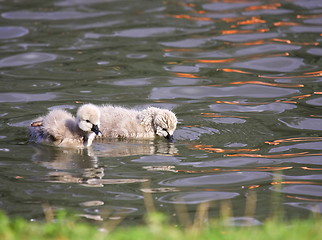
left=32, top=140, right=179, bottom=184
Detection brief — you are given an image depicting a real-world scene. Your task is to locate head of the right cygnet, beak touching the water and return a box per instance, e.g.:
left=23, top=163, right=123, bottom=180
left=153, top=109, right=177, bottom=142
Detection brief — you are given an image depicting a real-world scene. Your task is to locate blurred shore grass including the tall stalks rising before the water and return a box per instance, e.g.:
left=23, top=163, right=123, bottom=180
left=0, top=179, right=322, bottom=240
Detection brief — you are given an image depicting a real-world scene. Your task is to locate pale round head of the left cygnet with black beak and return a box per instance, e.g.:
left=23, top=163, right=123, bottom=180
left=77, top=104, right=102, bottom=135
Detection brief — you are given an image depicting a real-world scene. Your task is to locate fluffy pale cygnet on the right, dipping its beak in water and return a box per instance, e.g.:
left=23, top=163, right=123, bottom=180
left=99, top=105, right=177, bottom=142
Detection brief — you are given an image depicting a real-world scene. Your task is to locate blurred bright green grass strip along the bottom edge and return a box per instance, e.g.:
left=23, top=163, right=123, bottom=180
left=0, top=214, right=322, bottom=240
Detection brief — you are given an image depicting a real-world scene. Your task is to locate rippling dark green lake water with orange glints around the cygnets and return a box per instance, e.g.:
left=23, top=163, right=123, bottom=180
left=0, top=0, right=322, bottom=225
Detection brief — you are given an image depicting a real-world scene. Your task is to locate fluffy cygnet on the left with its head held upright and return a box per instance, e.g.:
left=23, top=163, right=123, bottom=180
left=29, top=104, right=101, bottom=148
